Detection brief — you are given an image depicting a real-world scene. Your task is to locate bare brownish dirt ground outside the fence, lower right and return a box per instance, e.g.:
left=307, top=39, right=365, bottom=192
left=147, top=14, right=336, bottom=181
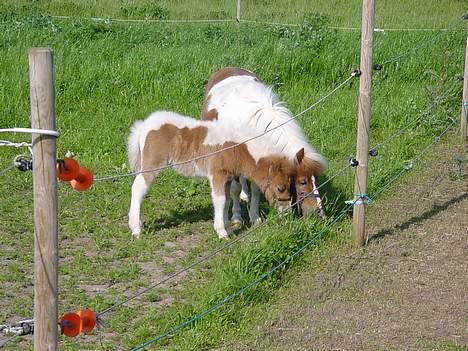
left=222, top=137, right=468, bottom=350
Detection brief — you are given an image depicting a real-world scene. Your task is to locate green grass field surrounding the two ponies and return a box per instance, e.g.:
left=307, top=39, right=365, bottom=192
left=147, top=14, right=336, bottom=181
left=0, top=0, right=468, bottom=350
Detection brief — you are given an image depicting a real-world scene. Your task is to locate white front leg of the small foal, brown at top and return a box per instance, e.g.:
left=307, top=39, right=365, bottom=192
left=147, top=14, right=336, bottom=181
left=209, top=175, right=231, bottom=239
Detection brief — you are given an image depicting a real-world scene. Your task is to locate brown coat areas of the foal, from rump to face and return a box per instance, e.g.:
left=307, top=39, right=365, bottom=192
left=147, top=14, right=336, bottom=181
left=142, top=123, right=294, bottom=204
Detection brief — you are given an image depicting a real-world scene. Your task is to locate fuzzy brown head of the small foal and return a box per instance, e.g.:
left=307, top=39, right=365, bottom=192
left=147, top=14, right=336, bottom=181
left=259, top=156, right=295, bottom=211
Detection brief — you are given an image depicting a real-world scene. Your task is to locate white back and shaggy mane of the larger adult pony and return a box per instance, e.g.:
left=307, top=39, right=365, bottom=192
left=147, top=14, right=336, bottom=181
left=207, top=75, right=327, bottom=169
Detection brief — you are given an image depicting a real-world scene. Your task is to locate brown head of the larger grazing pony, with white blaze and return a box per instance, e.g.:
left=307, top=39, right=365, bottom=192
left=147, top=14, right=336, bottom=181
left=291, top=149, right=325, bottom=219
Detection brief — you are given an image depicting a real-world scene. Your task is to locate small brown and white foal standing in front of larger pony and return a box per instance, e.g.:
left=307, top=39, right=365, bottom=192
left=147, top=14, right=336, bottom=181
left=128, top=111, right=300, bottom=238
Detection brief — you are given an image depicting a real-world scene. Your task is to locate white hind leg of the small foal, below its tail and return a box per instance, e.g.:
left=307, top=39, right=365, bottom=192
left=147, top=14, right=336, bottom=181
left=128, top=174, right=155, bottom=238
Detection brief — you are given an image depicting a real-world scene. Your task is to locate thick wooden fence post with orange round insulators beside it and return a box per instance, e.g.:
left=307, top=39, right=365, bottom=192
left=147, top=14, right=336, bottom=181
left=29, top=48, right=58, bottom=351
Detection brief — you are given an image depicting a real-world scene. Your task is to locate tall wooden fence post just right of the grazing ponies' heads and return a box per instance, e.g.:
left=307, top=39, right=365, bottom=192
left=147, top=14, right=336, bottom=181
left=353, top=0, right=375, bottom=246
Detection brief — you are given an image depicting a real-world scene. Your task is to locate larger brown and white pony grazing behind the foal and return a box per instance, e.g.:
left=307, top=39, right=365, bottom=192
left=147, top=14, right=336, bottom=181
left=201, top=67, right=326, bottom=221
